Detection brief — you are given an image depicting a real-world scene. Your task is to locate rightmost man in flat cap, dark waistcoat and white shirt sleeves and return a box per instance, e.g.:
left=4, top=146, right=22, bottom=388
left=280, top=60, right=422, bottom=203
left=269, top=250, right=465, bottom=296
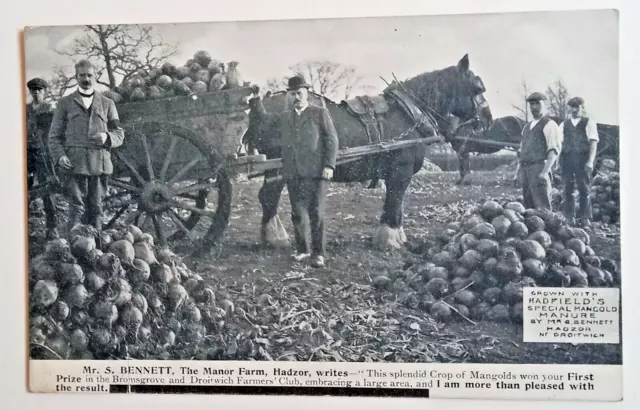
left=560, top=97, right=599, bottom=228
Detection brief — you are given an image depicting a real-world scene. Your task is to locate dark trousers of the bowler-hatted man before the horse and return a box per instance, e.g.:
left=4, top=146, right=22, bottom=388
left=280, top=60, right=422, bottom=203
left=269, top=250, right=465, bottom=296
left=287, top=177, right=327, bottom=256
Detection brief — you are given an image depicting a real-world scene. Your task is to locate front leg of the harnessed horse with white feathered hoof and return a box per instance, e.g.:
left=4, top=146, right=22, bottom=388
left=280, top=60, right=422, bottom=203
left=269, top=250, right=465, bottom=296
left=373, top=164, right=413, bottom=249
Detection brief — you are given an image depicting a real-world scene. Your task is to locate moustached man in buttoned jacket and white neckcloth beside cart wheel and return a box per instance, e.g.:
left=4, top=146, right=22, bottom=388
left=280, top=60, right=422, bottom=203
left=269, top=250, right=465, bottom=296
left=49, top=60, right=124, bottom=235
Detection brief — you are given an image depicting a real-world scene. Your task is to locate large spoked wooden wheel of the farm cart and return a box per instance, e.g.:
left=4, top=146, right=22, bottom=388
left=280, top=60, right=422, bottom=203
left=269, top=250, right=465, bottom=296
left=104, top=122, right=231, bottom=246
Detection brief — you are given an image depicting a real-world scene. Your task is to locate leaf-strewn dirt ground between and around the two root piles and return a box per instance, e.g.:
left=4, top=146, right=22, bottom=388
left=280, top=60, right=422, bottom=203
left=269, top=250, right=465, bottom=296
left=27, top=168, right=622, bottom=364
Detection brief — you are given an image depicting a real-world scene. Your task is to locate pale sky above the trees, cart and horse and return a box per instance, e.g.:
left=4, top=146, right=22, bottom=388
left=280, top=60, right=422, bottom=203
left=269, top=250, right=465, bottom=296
left=25, top=10, right=619, bottom=124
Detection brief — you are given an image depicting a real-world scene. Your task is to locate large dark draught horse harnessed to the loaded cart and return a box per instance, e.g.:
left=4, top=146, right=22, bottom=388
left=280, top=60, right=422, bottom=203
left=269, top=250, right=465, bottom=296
left=243, top=55, right=492, bottom=249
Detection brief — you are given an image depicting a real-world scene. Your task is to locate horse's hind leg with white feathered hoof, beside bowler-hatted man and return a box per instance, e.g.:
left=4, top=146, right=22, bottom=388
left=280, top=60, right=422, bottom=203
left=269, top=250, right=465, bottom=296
left=258, top=171, right=290, bottom=247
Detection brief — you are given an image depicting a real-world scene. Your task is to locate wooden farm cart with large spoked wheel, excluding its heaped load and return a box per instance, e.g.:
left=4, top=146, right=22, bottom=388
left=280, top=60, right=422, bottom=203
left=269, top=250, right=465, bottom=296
left=104, top=88, right=264, bottom=244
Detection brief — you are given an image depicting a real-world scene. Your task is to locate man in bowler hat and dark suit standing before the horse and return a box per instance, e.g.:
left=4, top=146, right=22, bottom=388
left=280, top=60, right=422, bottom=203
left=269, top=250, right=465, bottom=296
left=280, top=76, right=338, bottom=268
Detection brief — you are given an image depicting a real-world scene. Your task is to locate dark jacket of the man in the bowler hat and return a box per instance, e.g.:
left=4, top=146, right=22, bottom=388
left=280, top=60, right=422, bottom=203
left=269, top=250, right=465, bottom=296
left=280, top=105, right=338, bottom=179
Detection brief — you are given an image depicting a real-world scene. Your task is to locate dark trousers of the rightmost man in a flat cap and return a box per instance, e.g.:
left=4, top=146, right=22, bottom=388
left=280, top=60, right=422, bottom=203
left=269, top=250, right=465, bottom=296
left=560, top=152, right=592, bottom=219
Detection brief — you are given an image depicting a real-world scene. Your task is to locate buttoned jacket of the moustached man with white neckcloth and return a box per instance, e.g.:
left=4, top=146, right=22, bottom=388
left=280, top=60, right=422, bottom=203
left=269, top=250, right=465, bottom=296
left=49, top=91, right=124, bottom=175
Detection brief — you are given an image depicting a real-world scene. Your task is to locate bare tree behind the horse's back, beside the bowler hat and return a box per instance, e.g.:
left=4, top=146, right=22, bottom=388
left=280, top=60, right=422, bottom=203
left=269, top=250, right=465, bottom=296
left=289, top=60, right=363, bottom=100
